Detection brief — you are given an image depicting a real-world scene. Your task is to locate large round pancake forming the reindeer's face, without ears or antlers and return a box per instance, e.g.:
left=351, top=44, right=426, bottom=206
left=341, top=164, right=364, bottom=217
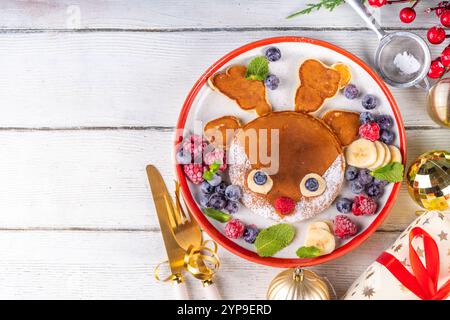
left=229, top=111, right=345, bottom=222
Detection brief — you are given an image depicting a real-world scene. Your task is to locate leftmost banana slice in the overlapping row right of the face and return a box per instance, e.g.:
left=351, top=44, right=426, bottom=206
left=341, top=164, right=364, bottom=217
left=345, top=138, right=377, bottom=168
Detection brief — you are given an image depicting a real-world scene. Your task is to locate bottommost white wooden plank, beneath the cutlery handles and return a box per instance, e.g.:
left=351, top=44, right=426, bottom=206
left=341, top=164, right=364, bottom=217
left=0, top=231, right=397, bottom=299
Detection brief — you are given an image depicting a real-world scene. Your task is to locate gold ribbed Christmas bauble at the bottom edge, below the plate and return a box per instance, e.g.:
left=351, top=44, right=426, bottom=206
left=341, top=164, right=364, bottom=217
left=267, top=268, right=330, bottom=300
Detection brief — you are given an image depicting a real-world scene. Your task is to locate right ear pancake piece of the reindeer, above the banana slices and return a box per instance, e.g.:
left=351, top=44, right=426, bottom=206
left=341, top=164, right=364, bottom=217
left=322, top=110, right=360, bottom=146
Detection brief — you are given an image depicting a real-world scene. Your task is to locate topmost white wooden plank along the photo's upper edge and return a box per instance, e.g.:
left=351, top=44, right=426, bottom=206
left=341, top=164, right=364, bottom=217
left=0, top=0, right=438, bottom=30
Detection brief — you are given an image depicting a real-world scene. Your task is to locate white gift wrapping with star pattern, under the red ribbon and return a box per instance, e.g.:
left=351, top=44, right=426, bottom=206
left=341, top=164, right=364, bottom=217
left=343, top=211, right=450, bottom=300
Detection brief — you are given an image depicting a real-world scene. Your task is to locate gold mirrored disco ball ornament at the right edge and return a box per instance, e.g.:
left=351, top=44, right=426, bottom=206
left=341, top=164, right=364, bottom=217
left=406, top=150, right=450, bottom=210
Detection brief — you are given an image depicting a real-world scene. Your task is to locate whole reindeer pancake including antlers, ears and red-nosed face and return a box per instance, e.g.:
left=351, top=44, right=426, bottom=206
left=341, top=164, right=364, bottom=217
left=205, top=60, right=354, bottom=222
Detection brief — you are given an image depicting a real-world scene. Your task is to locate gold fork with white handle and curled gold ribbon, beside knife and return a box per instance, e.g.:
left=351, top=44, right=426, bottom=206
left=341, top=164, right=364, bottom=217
left=168, top=181, right=222, bottom=300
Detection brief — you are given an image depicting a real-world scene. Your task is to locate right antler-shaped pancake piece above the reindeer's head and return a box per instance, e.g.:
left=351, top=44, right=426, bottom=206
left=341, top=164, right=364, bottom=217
left=295, top=59, right=341, bottom=113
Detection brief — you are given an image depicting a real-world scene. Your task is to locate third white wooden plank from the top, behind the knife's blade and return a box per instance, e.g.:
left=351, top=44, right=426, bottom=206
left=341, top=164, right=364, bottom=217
left=0, top=129, right=450, bottom=231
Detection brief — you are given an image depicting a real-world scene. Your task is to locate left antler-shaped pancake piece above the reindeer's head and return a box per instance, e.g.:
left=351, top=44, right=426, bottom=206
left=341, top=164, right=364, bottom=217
left=208, top=65, right=272, bottom=116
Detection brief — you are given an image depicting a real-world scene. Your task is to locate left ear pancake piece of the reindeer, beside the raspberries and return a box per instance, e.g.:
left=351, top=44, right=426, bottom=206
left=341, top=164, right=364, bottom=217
left=203, top=116, right=241, bottom=150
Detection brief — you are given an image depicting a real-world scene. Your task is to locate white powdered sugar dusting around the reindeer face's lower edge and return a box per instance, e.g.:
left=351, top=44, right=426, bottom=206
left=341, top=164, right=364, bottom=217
left=229, top=141, right=345, bottom=223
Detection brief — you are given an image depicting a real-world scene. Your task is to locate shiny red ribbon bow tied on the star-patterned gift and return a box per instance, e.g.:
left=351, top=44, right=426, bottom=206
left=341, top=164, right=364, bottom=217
left=377, top=227, right=450, bottom=300
